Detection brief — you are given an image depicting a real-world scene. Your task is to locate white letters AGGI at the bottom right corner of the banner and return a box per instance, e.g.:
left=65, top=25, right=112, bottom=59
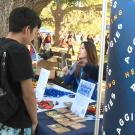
left=116, top=113, right=134, bottom=135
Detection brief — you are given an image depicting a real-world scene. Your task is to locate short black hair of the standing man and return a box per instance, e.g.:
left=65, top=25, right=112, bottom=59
left=9, top=7, right=41, bottom=32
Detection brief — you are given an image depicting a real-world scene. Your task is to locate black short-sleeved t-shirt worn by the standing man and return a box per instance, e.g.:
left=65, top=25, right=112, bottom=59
left=0, top=38, right=33, bottom=128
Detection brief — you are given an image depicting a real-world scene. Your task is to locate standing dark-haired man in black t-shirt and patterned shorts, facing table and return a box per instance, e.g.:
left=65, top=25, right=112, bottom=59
left=0, top=7, right=41, bottom=135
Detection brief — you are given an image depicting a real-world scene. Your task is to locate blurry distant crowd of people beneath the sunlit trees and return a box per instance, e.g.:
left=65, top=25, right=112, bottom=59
left=38, top=31, right=109, bottom=55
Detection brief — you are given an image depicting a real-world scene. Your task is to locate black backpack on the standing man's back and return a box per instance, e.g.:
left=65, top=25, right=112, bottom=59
left=0, top=44, right=19, bottom=123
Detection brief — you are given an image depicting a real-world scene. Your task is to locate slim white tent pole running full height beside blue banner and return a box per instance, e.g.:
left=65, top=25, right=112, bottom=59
left=94, top=0, right=107, bottom=135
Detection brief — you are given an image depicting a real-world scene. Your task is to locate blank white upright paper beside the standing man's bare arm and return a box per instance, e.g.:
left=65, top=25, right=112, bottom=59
left=36, top=68, right=50, bottom=101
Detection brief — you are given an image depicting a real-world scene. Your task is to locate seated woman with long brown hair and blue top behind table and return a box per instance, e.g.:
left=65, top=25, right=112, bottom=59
left=63, top=42, right=99, bottom=100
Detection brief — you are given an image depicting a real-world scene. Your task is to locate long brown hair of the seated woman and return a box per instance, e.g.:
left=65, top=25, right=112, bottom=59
left=75, top=41, right=98, bottom=77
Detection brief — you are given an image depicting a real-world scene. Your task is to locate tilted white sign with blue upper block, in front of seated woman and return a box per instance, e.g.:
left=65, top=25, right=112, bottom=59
left=71, top=80, right=95, bottom=118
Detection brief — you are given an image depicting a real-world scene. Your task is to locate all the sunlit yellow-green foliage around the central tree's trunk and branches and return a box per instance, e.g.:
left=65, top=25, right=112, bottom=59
left=40, top=0, right=102, bottom=35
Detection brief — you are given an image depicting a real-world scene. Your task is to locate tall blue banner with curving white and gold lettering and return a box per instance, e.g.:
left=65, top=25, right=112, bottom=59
left=103, top=0, right=135, bottom=135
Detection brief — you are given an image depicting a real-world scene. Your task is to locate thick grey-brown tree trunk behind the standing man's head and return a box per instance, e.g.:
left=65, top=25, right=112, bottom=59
left=0, top=0, right=52, bottom=37
